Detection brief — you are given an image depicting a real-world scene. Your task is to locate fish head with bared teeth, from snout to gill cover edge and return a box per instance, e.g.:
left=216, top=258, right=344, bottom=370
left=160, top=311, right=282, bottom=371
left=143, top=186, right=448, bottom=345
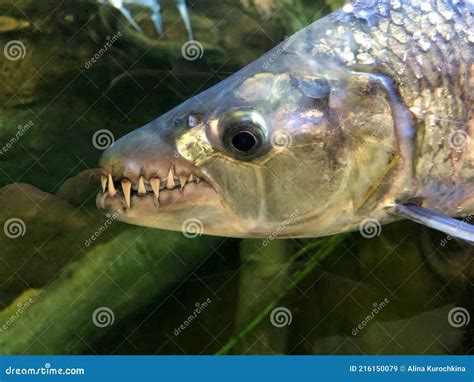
left=97, top=30, right=395, bottom=237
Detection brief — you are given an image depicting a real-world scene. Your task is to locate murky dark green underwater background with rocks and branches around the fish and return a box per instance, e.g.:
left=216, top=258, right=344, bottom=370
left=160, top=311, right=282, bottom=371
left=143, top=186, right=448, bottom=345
left=0, top=0, right=474, bottom=354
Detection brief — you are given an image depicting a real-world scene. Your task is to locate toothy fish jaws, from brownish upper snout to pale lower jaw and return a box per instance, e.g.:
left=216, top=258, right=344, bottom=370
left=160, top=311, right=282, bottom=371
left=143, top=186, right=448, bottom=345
left=96, top=128, right=239, bottom=235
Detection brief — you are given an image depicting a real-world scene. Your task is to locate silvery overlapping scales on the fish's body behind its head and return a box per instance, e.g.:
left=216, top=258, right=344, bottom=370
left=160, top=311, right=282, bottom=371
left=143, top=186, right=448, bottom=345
left=306, top=0, right=474, bottom=190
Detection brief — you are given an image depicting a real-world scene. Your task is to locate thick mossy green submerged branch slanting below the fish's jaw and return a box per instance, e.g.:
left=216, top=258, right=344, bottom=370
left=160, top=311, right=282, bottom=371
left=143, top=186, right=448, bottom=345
left=0, top=224, right=220, bottom=354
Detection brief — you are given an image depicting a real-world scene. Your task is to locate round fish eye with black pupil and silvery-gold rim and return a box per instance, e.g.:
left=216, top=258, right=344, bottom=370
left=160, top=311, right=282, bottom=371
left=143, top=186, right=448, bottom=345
left=219, top=110, right=268, bottom=160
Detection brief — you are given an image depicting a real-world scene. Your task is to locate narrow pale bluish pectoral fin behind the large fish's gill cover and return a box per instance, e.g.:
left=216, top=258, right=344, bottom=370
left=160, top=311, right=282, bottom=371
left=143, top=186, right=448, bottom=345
left=395, top=204, right=474, bottom=243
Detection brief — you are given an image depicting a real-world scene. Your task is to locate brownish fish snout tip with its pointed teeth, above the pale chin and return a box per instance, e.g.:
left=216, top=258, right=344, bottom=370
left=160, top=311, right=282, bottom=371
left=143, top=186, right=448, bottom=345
left=97, top=125, right=212, bottom=210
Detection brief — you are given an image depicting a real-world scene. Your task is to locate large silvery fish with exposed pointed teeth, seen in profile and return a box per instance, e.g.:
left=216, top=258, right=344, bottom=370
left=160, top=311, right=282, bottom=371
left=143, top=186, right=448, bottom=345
left=97, top=0, right=474, bottom=241
